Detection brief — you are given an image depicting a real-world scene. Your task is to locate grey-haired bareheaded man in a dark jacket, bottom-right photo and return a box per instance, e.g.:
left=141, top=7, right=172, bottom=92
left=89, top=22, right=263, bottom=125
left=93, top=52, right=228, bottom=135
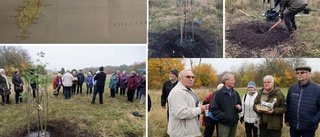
left=210, top=73, right=242, bottom=137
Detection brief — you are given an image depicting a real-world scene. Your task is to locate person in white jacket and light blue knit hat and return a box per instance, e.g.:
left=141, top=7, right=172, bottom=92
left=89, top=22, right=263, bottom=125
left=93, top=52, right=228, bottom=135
left=240, top=81, right=258, bottom=137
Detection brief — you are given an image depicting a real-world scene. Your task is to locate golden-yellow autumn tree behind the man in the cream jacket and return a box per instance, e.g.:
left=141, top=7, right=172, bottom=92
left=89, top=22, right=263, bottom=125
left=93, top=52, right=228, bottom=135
left=148, top=58, right=185, bottom=89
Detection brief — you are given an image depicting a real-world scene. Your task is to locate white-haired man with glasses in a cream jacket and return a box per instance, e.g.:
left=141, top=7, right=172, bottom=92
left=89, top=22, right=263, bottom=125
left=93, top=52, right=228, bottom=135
left=167, top=70, right=208, bottom=137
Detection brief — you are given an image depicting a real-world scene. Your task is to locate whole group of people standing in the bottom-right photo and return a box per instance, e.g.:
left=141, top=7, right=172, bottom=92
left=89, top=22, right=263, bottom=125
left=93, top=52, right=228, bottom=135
left=161, top=66, right=320, bottom=137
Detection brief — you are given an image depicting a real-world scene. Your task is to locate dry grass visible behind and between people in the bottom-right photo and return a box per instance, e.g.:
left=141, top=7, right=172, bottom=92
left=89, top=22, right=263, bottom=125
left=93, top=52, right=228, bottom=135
left=148, top=88, right=320, bottom=137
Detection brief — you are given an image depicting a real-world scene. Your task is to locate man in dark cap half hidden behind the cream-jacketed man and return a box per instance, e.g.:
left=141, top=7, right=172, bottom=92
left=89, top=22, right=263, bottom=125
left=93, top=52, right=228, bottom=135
left=161, top=69, right=178, bottom=121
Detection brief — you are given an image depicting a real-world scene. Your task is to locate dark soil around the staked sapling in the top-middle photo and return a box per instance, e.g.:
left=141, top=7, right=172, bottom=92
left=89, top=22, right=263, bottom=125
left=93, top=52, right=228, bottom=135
left=148, top=30, right=216, bottom=58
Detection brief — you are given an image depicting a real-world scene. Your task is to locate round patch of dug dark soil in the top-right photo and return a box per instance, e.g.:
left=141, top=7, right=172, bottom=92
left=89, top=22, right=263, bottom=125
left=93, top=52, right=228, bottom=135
left=226, top=21, right=290, bottom=49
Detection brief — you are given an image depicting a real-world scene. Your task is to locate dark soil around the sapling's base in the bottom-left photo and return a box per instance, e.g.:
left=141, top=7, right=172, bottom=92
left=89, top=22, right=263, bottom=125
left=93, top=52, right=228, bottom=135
left=11, top=119, right=97, bottom=137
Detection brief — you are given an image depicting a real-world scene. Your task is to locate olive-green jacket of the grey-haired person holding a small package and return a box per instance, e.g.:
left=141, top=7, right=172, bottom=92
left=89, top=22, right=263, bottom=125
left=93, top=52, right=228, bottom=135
left=253, top=87, right=287, bottom=130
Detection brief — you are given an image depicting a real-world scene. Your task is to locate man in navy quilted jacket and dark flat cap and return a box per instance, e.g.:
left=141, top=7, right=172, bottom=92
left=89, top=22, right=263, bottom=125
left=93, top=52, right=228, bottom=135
left=285, top=66, right=320, bottom=137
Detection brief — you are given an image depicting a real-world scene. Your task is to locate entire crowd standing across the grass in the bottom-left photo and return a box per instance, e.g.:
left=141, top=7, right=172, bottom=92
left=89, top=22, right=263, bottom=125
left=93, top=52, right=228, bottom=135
left=0, top=67, right=146, bottom=105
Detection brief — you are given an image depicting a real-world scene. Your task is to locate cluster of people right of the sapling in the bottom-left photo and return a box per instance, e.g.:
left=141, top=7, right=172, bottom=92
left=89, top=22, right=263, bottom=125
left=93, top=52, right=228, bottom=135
left=53, top=67, right=146, bottom=104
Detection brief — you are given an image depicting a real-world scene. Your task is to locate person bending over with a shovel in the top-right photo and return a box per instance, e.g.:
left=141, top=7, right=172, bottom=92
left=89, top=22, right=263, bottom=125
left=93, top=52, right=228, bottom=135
left=275, top=0, right=307, bottom=35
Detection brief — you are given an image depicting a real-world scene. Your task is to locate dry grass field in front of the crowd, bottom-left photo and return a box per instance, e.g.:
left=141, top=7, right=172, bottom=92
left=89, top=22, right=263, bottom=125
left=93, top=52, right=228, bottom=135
left=0, top=77, right=146, bottom=137
